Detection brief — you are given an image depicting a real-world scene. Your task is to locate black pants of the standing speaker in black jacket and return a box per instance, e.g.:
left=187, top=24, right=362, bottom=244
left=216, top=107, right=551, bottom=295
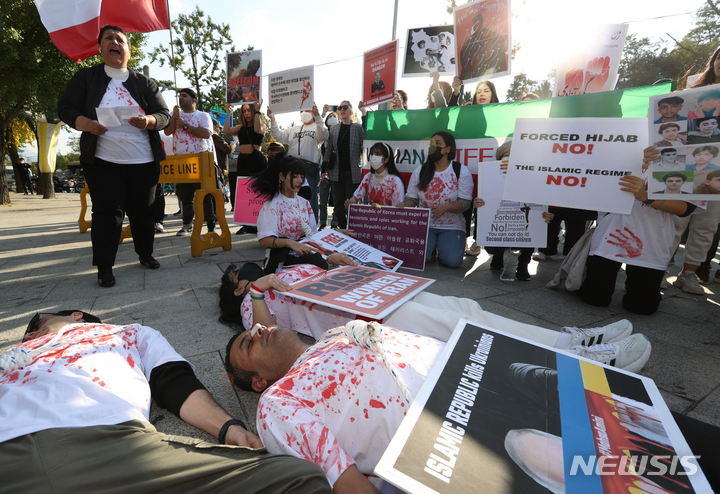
left=83, top=158, right=160, bottom=266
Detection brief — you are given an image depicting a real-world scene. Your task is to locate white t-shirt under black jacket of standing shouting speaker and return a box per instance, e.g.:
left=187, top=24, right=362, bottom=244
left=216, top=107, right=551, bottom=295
left=95, top=77, right=155, bottom=164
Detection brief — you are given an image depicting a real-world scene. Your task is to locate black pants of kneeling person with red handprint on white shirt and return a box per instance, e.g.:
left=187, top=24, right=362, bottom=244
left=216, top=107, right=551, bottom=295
left=578, top=256, right=665, bottom=315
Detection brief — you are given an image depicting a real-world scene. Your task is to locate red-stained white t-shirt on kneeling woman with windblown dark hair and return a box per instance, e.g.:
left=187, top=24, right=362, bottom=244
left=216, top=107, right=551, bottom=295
left=257, top=194, right=317, bottom=240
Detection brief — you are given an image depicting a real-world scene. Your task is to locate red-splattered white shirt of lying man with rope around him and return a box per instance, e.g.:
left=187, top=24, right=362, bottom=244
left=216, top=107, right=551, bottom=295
left=257, top=326, right=445, bottom=484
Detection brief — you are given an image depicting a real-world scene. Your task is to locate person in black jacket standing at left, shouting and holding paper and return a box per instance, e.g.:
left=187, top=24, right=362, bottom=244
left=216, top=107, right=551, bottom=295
left=58, top=26, right=170, bottom=287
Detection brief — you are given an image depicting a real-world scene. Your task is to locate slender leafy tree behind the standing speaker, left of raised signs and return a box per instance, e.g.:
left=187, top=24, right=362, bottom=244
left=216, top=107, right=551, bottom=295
left=150, top=7, right=235, bottom=111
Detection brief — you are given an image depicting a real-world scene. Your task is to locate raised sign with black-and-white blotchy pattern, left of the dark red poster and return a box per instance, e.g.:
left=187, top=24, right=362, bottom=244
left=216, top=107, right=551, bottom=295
left=402, top=26, right=457, bottom=77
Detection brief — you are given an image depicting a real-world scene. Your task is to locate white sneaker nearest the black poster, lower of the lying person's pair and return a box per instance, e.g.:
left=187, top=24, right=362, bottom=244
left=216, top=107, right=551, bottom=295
left=568, top=333, right=652, bottom=372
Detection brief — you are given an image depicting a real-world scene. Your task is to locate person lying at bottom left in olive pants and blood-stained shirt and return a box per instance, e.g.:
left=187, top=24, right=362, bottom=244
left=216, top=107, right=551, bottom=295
left=0, top=310, right=330, bottom=494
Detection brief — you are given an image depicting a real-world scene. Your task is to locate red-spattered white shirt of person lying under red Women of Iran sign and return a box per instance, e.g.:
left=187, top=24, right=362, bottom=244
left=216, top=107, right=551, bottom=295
left=241, top=264, right=357, bottom=340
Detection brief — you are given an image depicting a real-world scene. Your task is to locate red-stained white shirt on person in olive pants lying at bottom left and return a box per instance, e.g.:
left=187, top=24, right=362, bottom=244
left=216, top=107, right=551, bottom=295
left=0, top=324, right=185, bottom=443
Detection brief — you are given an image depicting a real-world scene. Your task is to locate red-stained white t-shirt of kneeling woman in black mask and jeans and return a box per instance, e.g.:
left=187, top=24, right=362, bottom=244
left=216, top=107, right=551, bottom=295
left=405, top=163, right=473, bottom=231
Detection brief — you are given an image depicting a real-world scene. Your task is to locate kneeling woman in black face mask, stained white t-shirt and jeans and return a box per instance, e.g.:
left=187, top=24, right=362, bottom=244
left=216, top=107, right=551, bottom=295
left=396, top=132, right=473, bottom=268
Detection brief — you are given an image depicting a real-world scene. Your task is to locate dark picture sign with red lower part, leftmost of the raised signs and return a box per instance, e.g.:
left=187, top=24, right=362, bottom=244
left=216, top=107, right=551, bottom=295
left=225, top=50, right=262, bottom=105
